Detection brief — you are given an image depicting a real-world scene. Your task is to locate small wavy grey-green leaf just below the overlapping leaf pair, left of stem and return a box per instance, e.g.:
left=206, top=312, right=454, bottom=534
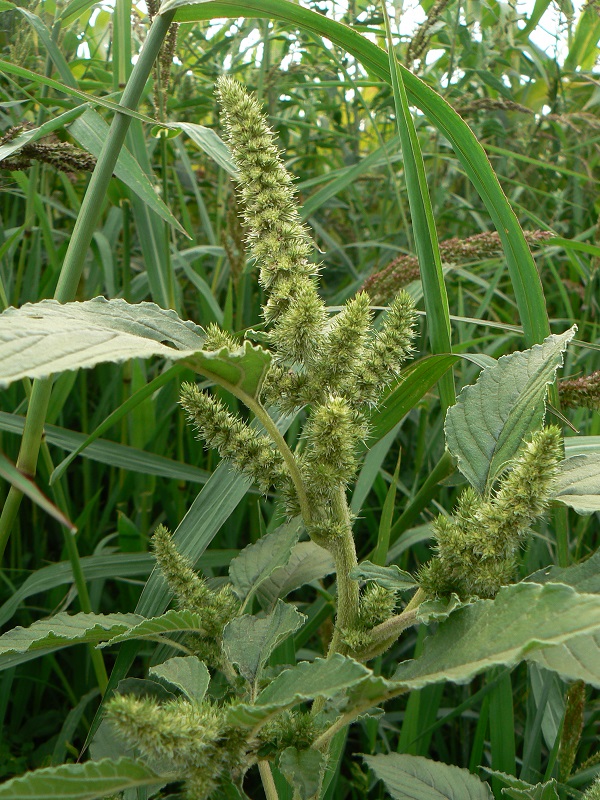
left=223, top=600, right=306, bottom=684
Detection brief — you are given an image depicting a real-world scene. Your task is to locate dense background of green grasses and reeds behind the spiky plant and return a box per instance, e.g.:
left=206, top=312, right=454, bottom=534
left=0, top=0, right=600, bottom=798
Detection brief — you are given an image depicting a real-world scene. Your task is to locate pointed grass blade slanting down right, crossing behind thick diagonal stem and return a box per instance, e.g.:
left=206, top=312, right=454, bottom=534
left=69, top=108, right=187, bottom=236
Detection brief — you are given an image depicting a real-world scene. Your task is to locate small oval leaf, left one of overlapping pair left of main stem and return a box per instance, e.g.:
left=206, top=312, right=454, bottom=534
left=229, top=518, right=302, bottom=605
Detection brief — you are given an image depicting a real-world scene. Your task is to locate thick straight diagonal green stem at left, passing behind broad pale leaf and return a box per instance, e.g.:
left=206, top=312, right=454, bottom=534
left=0, top=11, right=175, bottom=559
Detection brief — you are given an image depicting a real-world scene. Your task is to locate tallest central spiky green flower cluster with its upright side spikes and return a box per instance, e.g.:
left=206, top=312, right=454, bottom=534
left=182, top=77, right=415, bottom=544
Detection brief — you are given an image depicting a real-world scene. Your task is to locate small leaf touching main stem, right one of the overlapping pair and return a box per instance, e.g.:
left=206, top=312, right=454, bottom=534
left=257, top=542, right=335, bottom=608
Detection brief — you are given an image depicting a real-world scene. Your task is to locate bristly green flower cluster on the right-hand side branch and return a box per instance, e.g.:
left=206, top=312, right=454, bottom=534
left=420, top=426, right=562, bottom=599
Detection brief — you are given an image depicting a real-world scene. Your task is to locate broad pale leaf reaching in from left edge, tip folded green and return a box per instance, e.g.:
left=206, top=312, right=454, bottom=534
left=0, top=297, right=271, bottom=397
